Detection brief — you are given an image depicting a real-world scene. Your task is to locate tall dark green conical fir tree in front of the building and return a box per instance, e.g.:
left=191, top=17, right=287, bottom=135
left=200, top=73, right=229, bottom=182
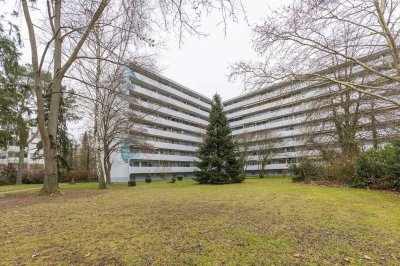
left=194, top=94, right=244, bottom=184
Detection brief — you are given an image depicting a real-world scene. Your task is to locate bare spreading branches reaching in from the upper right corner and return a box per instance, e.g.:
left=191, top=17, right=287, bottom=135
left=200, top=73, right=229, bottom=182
left=231, top=0, right=400, bottom=108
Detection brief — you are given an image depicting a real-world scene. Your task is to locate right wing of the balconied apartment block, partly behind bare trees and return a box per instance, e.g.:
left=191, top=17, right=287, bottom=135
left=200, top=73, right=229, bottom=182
left=224, top=53, right=400, bottom=175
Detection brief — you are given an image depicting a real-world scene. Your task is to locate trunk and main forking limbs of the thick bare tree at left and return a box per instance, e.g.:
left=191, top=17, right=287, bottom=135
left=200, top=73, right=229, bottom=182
left=21, top=0, right=109, bottom=194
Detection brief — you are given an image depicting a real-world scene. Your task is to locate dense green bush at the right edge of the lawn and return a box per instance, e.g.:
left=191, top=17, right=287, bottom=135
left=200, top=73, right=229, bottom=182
left=353, top=144, right=400, bottom=191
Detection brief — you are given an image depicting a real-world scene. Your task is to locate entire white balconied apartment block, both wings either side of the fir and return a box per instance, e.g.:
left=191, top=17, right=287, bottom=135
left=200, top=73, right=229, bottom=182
left=112, top=51, right=400, bottom=182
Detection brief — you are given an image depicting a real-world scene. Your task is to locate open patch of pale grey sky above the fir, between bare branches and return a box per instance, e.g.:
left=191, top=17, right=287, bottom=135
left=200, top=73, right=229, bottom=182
left=159, top=0, right=284, bottom=100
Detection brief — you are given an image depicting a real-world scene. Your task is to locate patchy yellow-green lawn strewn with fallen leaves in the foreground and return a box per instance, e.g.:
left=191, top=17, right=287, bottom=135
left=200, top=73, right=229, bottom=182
left=0, top=178, right=400, bottom=265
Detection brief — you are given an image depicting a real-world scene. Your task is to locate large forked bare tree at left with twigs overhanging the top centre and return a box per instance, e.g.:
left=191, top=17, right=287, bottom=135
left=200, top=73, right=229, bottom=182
left=21, top=0, right=242, bottom=194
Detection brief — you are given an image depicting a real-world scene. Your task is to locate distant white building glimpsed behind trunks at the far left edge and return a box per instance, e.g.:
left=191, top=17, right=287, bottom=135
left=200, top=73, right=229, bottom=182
left=0, top=127, right=44, bottom=168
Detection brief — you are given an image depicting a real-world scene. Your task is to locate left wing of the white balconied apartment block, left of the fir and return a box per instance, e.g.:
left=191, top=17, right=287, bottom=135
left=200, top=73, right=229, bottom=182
left=111, top=67, right=211, bottom=182
